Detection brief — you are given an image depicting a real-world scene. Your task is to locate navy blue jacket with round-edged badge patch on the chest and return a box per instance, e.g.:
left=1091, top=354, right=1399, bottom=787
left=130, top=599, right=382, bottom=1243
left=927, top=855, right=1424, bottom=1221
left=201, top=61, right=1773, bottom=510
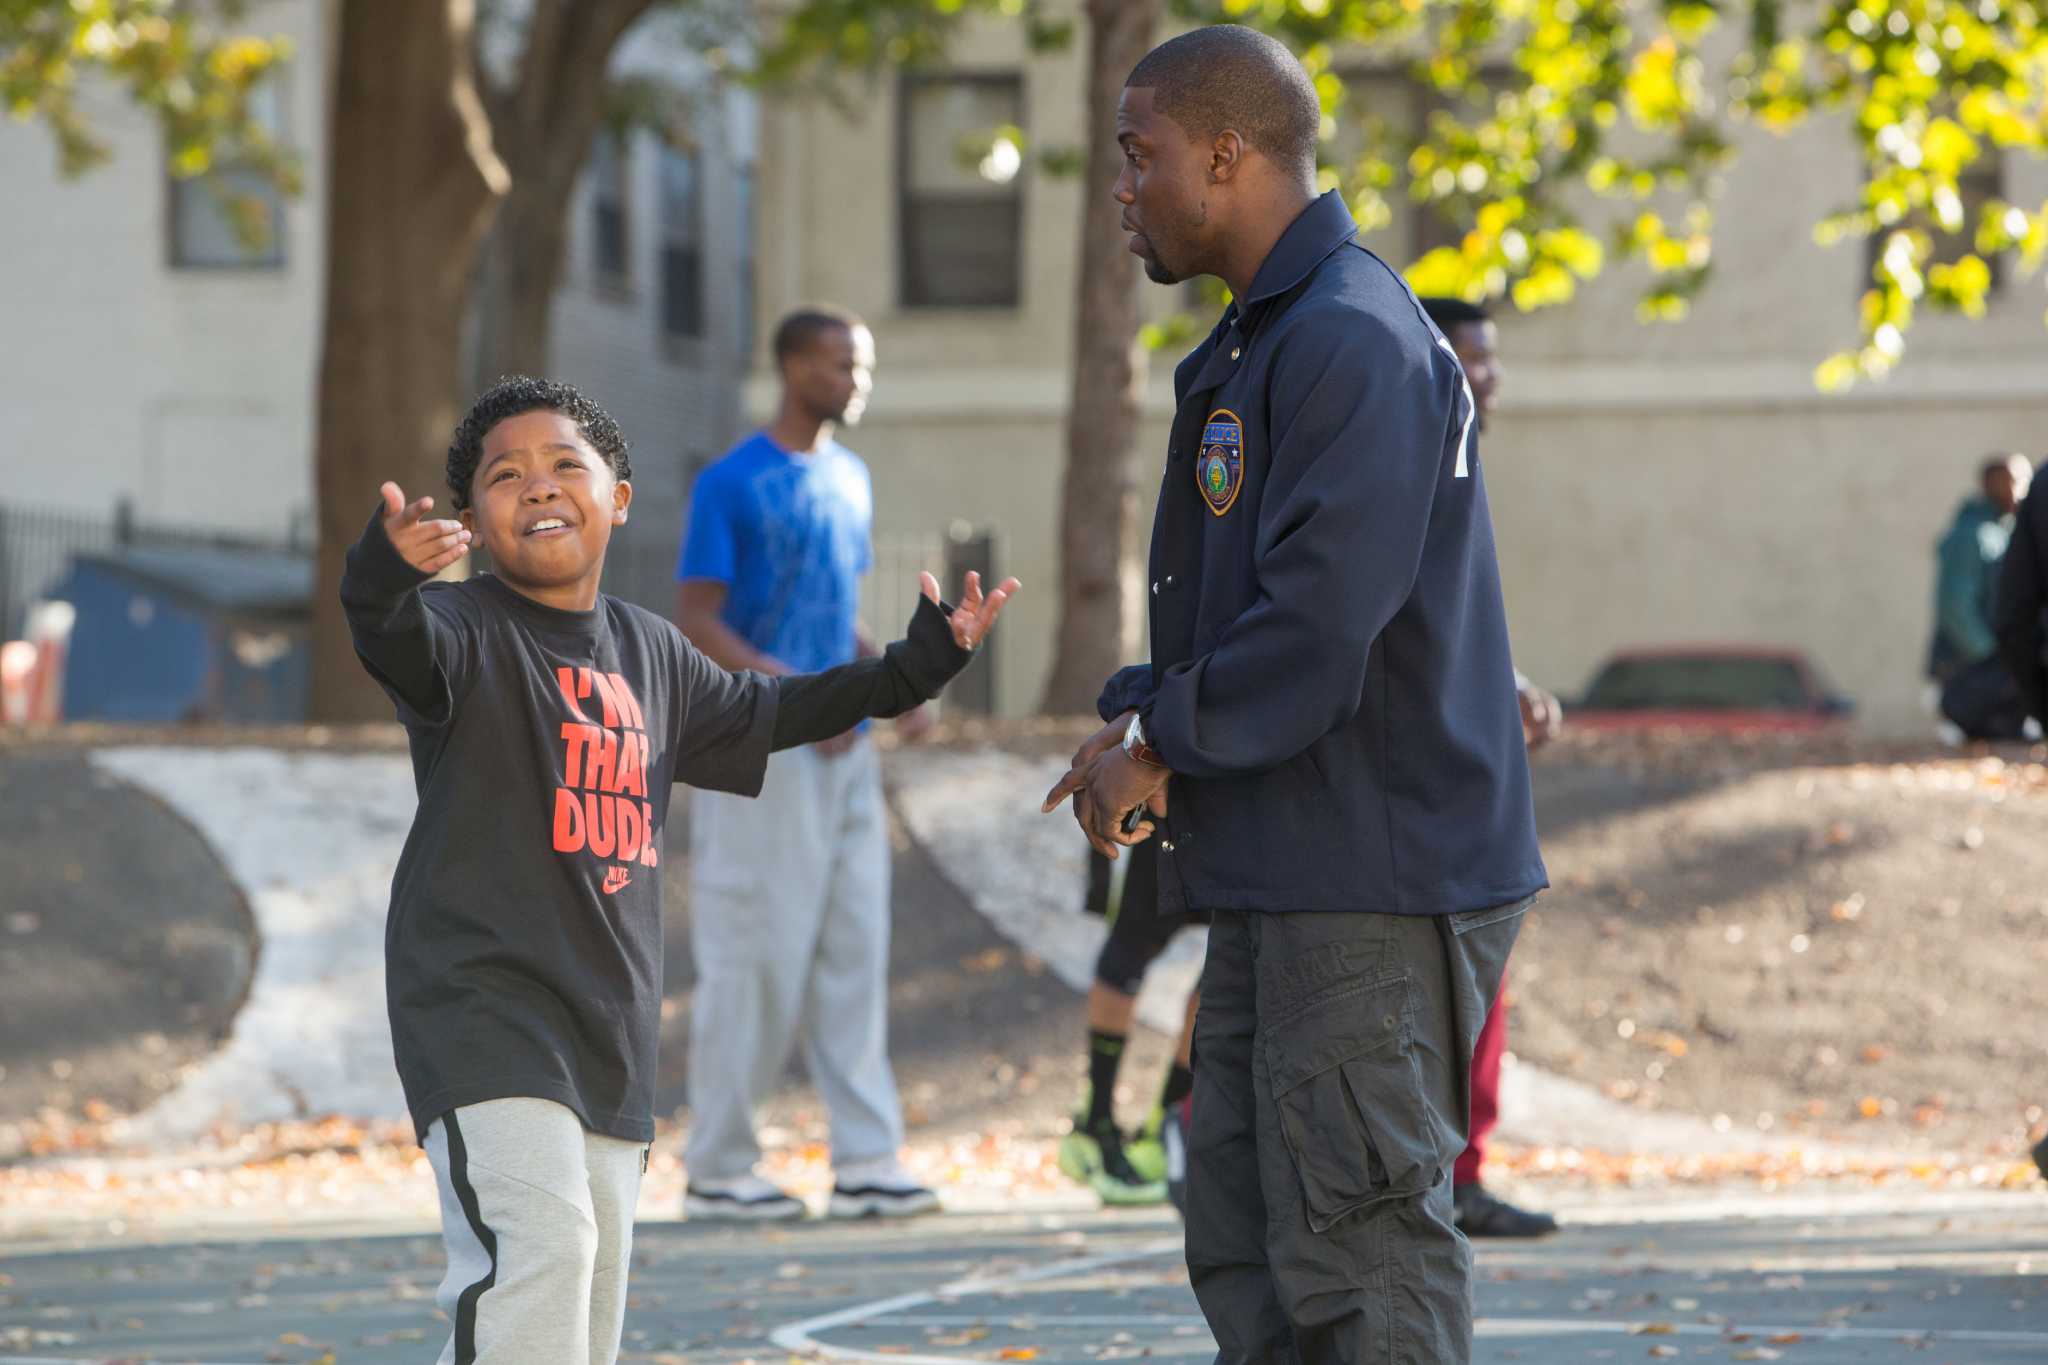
left=1100, top=192, right=1548, bottom=915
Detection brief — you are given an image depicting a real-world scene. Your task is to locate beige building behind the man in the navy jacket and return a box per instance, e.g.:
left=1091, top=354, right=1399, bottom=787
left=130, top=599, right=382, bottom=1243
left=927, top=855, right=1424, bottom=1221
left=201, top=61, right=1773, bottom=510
left=750, top=13, right=2048, bottom=733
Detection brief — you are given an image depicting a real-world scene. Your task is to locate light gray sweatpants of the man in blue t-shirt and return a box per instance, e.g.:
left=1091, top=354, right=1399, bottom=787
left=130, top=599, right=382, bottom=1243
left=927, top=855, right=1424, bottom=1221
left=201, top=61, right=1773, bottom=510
left=684, top=739, right=903, bottom=1181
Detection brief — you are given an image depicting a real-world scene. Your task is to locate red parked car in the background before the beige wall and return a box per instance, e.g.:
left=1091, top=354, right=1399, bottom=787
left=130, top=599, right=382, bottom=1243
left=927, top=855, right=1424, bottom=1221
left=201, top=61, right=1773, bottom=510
left=1565, top=645, right=1855, bottom=733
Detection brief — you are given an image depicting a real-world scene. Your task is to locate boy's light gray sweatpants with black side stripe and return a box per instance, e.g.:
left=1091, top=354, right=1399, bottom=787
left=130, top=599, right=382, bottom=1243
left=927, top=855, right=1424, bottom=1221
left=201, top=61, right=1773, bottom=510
left=426, top=1099, right=647, bottom=1365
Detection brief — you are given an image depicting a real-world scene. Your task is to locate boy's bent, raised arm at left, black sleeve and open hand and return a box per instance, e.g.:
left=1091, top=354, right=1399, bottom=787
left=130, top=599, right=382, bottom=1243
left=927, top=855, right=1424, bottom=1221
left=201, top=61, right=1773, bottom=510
left=342, top=483, right=469, bottom=722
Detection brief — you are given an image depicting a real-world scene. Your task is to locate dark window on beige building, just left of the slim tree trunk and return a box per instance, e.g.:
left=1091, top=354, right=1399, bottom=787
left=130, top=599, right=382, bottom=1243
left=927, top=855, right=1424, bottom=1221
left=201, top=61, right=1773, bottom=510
left=897, top=76, right=1024, bottom=307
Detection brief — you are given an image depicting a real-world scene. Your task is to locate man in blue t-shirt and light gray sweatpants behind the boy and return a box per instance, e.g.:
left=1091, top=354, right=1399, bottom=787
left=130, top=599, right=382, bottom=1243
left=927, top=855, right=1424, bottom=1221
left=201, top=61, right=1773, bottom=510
left=676, top=309, right=938, bottom=1222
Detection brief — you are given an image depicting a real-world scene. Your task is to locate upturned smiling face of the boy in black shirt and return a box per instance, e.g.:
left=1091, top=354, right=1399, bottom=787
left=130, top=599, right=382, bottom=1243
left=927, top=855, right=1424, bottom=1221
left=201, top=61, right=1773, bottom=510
left=463, top=409, right=633, bottom=610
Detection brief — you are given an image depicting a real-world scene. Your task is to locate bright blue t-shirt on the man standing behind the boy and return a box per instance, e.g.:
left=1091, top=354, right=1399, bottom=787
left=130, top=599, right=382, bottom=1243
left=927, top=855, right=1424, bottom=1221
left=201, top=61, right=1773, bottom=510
left=676, top=432, right=874, bottom=673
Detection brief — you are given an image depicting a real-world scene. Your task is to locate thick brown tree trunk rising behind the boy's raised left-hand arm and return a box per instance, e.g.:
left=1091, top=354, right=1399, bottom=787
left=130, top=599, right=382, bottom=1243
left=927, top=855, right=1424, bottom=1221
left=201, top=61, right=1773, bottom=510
left=311, top=0, right=508, bottom=720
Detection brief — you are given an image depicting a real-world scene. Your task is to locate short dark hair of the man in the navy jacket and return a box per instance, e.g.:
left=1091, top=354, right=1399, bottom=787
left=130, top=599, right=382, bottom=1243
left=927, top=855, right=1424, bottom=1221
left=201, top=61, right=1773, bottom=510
left=1124, top=25, right=1323, bottom=174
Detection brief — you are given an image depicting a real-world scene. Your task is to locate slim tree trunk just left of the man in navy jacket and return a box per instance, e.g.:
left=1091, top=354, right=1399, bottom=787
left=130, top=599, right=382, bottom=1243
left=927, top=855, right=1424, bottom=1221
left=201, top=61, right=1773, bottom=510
left=1042, top=0, right=1161, bottom=714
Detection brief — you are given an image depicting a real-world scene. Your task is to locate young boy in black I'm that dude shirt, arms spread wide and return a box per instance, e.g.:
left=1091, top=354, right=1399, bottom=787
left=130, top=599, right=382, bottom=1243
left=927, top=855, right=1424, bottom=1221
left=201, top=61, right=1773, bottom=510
left=342, top=379, right=1016, bottom=1365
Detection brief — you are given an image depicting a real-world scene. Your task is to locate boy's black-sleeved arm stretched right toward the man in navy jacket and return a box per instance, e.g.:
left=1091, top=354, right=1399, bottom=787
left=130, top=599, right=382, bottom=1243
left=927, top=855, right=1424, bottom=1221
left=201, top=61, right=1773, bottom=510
left=772, top=573, right=1018, bottom=749
